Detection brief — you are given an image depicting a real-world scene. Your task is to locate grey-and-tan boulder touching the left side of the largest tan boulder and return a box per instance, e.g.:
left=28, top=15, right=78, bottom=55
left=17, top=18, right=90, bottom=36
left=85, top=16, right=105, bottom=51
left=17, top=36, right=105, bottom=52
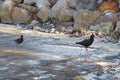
left=58, top=7, right=74, bottom=22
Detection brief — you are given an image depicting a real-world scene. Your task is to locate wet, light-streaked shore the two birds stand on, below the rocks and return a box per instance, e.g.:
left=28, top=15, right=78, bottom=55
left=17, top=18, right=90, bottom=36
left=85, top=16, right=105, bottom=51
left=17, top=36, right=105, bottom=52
left=0, top=24, right=120, bottom=80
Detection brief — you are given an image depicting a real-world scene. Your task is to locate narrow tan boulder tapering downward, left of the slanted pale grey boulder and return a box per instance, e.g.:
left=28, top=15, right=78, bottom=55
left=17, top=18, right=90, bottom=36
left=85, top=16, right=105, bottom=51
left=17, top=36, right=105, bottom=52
left=37, top=6, right=50, bottom=22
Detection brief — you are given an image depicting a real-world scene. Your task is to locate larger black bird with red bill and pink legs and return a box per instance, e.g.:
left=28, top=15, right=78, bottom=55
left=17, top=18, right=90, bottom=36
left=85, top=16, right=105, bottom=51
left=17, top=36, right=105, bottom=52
left=75, top=34, right=96, bottom=51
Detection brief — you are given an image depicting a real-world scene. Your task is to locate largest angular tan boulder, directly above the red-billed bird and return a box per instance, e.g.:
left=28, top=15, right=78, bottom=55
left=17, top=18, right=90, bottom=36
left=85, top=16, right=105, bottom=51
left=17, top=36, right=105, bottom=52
left=73, top=10, right=100, bottom=30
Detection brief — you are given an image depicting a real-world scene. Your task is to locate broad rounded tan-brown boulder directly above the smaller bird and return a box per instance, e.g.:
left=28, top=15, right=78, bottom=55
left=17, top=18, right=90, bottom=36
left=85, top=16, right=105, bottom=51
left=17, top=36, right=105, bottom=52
left=12, top=7, right=32, bottom=23
